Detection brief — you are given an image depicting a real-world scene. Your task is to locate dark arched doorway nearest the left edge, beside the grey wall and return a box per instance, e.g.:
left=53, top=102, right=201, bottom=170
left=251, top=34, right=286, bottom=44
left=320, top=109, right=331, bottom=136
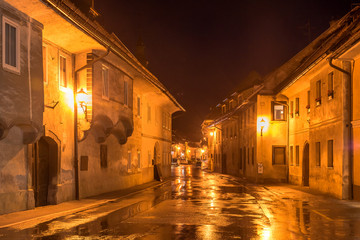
left=33, top=137, right=58, bottom=207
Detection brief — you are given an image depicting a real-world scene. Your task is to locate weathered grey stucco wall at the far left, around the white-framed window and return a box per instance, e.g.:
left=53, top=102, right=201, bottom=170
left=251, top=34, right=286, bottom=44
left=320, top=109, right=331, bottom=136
left=0, top=1, right=44, bottom=214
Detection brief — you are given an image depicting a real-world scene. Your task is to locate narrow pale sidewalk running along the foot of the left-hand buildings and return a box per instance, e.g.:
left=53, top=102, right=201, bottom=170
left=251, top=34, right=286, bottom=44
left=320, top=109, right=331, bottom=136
left=0, top=178, right=171, bottom=229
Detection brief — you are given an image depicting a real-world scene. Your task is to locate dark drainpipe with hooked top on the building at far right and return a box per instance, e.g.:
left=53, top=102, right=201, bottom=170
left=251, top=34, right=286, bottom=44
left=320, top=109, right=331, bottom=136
left=328, top=57, right=353, bottom=199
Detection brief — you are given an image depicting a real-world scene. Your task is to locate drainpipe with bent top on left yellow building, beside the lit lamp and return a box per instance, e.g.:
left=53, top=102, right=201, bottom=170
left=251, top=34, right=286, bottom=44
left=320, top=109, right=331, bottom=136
left=74, top=48, right=110, bottom=200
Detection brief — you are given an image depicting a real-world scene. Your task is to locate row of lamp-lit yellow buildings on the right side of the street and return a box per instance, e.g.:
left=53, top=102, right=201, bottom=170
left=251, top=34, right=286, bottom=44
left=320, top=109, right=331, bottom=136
left=203, top=7, right=360, bottom=199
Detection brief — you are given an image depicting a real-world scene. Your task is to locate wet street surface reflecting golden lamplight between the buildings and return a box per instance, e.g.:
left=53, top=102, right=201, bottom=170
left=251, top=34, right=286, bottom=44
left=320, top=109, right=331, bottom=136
left=0, top=165, right=360, bottom=240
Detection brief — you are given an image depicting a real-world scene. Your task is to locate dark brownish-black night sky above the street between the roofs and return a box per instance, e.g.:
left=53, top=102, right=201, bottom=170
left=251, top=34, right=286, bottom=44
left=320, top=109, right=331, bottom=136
left=95, top=0, right=351, bottom=141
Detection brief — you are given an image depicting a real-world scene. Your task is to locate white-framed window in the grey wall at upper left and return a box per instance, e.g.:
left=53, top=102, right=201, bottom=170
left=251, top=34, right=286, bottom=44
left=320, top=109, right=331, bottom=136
left=2, top=17, right=20, bottom=73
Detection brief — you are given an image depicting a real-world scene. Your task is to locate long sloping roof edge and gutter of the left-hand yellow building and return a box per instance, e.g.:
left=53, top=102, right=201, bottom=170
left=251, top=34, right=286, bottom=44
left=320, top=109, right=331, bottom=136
left=41, top=0, right=185, bottom=112
